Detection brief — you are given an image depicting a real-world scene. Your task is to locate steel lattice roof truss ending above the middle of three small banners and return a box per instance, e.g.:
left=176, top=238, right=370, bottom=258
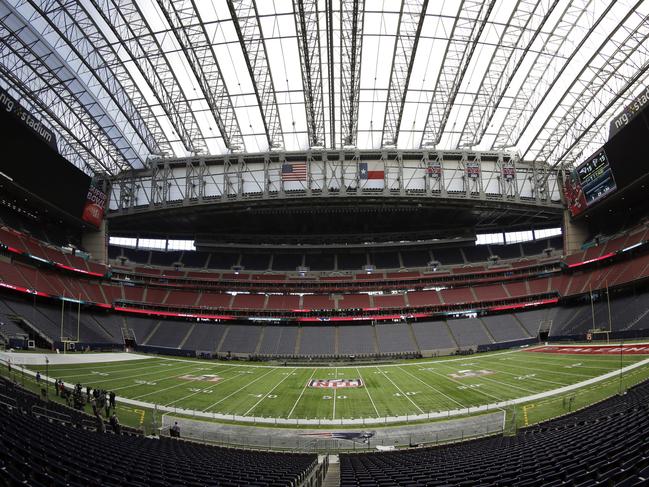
left=458, top=0, right=559, bottom=148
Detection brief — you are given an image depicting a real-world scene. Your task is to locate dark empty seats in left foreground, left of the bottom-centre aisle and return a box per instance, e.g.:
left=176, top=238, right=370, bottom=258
left=0, top=388, right=317, bottom=487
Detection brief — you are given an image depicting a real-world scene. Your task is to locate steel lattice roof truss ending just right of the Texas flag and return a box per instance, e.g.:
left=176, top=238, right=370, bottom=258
left=381, top=0, right=428, bottom=147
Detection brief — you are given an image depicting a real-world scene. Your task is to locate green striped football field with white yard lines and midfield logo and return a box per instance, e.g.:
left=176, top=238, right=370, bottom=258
left=30, top=347, right=649, bottom=426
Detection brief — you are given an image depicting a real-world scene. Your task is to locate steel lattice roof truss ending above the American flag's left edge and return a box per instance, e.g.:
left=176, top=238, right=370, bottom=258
left=228, top=0, right=284, bottom=150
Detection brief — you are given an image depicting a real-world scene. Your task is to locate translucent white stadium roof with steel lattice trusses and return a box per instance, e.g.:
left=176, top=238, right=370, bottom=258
left=0, top=0, right=649, bottom=175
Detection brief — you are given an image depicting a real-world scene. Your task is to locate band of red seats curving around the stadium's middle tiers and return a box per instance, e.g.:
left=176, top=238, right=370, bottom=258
left=0, top=227, right=649, bottom=322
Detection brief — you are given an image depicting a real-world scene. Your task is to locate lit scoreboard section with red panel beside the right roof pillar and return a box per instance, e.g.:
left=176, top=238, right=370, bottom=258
left=563, top=149, right=617, bottom=217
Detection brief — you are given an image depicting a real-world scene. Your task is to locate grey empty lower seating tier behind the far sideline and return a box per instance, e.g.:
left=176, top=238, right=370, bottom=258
left=0, top=286, right=649, bottom=356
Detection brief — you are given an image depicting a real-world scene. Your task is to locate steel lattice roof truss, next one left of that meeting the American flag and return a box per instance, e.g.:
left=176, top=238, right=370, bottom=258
left=158, top=0, right=245, bottom=152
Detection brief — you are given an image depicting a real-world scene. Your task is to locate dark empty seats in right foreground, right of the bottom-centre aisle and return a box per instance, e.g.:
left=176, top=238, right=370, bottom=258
left=340, top=382, right=649, bottom=487
